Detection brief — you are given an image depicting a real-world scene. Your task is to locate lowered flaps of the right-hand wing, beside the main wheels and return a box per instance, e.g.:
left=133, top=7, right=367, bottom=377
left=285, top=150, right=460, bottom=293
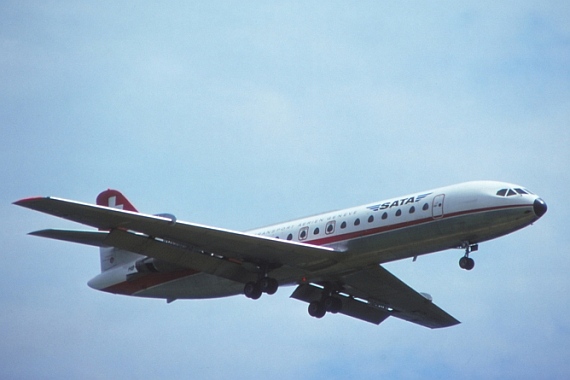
left=291, top=284, right=390, bottom=325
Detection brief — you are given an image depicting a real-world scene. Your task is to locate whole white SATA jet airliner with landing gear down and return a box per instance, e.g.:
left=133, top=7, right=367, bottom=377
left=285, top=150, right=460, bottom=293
left=14, top=181, right=547, bottom=328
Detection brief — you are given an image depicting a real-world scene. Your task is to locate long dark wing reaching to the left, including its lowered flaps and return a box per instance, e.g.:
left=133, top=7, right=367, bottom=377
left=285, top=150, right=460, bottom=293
left=16, top=198, right=342, bottom=290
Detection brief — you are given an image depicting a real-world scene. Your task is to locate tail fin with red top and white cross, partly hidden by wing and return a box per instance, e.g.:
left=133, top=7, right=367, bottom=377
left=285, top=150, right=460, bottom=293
left=97, top=189, right=143, bottom=272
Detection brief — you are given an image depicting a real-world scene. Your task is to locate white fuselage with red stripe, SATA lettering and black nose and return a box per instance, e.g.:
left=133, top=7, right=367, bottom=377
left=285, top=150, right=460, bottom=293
left=89, top=181, right=545, bottom=299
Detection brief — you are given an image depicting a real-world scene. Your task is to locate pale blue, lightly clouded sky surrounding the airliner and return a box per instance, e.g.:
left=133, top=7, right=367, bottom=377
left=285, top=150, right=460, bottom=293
left=0, top=0, right=570, bottom=380
